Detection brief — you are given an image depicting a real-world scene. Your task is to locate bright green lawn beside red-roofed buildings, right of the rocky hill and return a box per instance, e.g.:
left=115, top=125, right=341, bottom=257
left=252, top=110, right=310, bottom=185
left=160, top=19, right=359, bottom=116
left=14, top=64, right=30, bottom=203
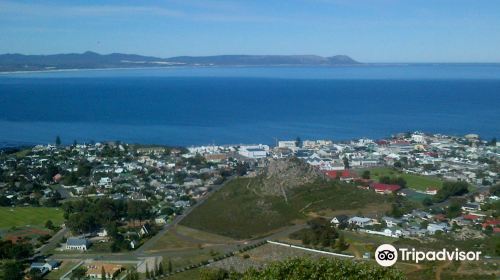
left=368, top=167, right=443, bottom=191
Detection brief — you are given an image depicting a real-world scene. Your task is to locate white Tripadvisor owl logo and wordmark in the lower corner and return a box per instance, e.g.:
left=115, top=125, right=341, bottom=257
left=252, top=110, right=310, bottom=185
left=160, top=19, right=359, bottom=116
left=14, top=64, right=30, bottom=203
left=375, top=244, right=481, bottom=267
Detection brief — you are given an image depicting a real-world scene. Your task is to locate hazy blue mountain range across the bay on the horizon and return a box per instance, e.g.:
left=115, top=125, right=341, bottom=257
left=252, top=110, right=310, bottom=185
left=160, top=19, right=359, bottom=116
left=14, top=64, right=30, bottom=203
left=0, top=51, right=360, bottom=72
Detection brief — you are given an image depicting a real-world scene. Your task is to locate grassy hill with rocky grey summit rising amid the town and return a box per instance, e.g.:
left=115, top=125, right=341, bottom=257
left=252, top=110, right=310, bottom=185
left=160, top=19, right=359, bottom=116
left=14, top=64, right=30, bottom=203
left=181, top=160, right=385, bottom=239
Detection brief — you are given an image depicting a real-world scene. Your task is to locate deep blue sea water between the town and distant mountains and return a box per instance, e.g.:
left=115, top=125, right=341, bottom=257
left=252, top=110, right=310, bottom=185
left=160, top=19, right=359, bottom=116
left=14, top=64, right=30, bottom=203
left=0, top=64, right=500, bottom=146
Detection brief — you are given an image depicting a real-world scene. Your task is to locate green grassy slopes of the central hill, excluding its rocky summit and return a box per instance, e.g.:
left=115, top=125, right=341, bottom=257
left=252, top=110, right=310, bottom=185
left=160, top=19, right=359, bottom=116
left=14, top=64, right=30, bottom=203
left=181, top=178, right=386, bottom=239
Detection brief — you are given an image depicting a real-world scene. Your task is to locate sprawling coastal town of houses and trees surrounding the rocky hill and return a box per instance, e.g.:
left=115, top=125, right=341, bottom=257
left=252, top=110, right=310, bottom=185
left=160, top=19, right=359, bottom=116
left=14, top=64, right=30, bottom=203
left=0, top=132, right=500, bottom=279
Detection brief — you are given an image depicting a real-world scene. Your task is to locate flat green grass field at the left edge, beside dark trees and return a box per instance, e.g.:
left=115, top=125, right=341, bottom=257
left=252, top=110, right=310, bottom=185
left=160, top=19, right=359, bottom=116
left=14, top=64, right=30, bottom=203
left=0, top=207, right=64, bottom=229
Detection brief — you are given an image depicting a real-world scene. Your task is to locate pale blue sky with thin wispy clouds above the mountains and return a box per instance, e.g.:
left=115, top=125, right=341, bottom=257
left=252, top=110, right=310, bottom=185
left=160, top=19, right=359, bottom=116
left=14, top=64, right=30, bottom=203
left=0, top=0, right=500, bottom=62
